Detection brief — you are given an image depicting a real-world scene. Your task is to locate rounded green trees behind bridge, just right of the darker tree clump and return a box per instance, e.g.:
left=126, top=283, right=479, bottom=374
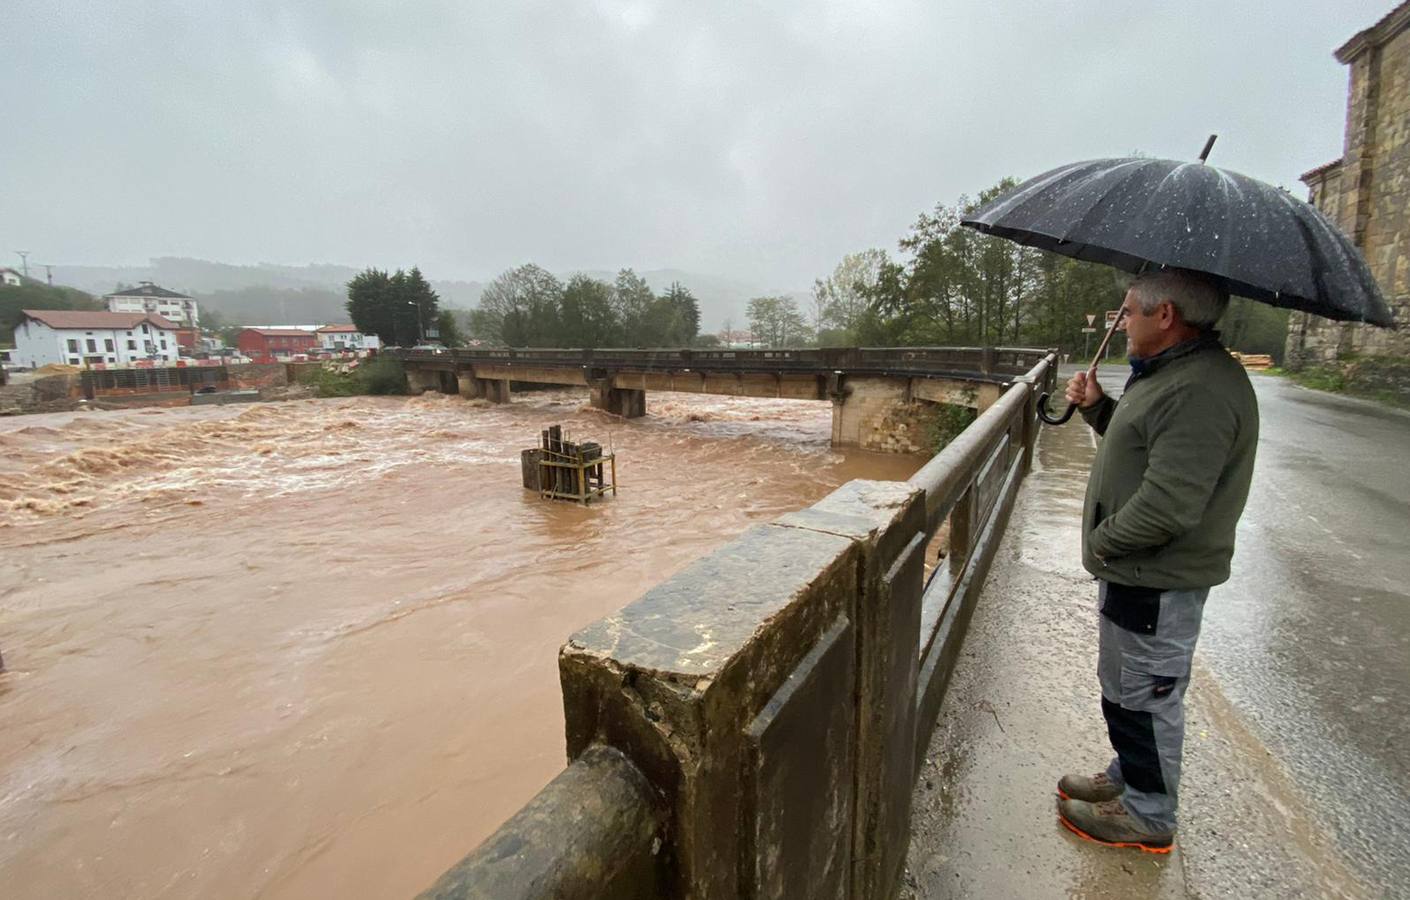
left=470, top=262, right=705, bottom=347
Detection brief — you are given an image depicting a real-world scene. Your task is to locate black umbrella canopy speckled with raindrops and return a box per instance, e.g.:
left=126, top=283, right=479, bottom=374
left=962, top=158, right=1393, bottom=326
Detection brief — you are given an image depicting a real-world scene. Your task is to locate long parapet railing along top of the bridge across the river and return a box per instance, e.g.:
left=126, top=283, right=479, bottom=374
left=393, top=341, right=1045, bottom=375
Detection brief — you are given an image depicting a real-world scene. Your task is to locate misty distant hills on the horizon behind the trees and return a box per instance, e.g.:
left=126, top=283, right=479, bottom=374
left=54, top=257, right=811, bottom=332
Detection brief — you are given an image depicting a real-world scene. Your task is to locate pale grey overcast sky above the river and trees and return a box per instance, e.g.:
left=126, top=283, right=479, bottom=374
left=0, top=0, right=1394, bottom=289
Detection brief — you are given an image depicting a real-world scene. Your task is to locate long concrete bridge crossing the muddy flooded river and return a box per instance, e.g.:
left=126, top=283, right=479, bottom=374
left=391, top=347, right=1046, bottom=451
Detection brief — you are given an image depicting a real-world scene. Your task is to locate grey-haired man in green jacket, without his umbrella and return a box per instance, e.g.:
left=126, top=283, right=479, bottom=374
left=1058, top=269, right=1258, bottom=852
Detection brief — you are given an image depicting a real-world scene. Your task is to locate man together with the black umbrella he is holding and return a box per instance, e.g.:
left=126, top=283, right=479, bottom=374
left=963, top=146, right=1392, bottom=853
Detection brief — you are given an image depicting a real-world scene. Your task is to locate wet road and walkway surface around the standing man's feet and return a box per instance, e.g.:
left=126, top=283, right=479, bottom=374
left=908, top=370, right=1410, bottom=897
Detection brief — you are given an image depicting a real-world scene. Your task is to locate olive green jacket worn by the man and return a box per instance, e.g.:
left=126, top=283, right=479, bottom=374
left=1081, top=334, right=1258, bottom=590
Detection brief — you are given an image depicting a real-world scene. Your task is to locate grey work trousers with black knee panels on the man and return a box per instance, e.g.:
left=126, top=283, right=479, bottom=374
left=1097, top=581, right=1210, bottom=832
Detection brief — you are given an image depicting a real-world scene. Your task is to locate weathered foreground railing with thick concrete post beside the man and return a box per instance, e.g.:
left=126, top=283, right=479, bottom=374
left=423, top=354, right=1056, bottom=900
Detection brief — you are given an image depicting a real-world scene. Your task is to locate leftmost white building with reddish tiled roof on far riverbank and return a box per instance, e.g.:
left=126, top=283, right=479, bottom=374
left=13, top=309, right=178, bottom=368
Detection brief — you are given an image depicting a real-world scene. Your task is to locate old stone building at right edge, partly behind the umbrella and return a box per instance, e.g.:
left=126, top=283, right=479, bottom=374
left=1287, top=1, right=1410, bottom=368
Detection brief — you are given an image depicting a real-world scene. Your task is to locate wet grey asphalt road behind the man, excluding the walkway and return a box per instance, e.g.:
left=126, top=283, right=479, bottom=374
left=1201, top=377, right=1410, bottom=894
